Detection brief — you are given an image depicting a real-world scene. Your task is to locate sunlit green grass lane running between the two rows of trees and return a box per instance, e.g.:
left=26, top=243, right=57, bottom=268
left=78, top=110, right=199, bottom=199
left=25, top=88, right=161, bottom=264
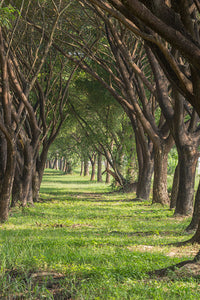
left=0, top=170, right=200, bottom=300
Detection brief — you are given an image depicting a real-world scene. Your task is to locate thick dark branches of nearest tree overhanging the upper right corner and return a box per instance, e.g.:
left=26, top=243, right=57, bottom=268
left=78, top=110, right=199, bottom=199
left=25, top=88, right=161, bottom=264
left=84, top=0, right=200, bottom=248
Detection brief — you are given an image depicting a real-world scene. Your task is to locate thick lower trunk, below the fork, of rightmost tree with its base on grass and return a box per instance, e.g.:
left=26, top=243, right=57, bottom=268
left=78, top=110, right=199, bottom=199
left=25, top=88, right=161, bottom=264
left=175, top=145, right=198, bottom=216
